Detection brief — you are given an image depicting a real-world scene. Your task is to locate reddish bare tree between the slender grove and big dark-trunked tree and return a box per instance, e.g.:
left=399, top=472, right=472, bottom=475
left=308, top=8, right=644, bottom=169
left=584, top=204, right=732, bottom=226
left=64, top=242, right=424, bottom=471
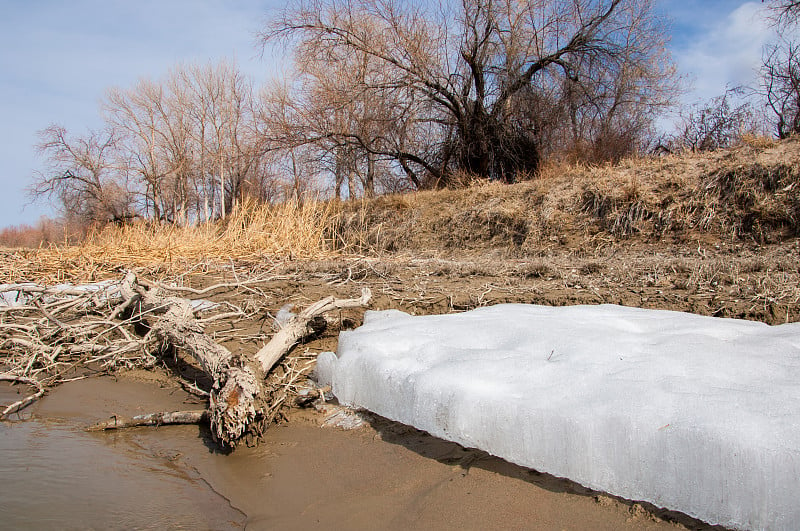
left=263, top=43, right=424, bottom=197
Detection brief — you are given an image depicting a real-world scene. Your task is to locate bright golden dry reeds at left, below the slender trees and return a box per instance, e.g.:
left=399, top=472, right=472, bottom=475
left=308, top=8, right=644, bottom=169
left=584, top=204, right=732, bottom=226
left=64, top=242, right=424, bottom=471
left=0, top=201, right=347, bottom=283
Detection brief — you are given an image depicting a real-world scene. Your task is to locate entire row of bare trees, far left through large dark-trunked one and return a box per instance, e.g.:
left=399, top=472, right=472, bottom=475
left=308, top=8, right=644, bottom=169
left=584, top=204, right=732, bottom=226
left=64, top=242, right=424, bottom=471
left=31, top=0, right=677, bottom=224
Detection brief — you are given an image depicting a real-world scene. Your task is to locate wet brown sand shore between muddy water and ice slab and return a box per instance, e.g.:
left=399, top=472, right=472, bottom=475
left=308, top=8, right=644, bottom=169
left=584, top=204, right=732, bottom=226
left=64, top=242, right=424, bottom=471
left=4, top=371, right=723, bottom=531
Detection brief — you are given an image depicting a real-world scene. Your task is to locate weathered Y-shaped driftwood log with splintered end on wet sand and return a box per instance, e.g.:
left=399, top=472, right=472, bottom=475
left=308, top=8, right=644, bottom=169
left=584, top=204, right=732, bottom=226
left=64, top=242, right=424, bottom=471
left=101, top=273, right=372, bottom=446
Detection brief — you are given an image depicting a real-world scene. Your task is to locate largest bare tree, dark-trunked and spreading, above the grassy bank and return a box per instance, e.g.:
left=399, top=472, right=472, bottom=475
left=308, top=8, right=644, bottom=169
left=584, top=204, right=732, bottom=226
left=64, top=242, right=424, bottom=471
left=261, top=0, right=674, bottom=186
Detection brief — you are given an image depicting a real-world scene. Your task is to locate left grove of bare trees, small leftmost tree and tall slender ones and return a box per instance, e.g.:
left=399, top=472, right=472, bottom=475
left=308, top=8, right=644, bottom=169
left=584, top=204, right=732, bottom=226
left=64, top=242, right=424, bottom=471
left=30, top=62, right=275, bottom=224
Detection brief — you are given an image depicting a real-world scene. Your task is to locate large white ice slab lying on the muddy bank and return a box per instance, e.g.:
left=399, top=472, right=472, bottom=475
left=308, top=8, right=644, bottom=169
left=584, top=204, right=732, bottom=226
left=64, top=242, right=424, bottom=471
left=317, top=304, right=800, bottom=530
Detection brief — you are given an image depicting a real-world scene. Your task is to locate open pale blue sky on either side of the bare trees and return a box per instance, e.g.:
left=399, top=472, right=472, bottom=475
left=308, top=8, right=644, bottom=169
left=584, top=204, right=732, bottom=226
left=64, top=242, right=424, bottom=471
left=0, top=0, right=770, bottom=227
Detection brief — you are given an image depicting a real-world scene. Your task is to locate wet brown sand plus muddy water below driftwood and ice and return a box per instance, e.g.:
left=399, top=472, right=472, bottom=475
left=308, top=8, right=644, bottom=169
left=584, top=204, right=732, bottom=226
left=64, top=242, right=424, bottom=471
left=0, top=372, right=720, bottom=530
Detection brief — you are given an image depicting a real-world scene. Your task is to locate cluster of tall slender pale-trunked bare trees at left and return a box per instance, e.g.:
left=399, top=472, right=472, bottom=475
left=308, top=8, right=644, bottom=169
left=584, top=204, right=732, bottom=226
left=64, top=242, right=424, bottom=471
left=105, top=61, right=265, bottom=223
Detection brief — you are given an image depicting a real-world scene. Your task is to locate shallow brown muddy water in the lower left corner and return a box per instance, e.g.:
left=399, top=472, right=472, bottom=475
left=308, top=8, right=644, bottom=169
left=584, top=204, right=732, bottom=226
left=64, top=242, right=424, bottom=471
left=0, top=382, right=246, bottom=529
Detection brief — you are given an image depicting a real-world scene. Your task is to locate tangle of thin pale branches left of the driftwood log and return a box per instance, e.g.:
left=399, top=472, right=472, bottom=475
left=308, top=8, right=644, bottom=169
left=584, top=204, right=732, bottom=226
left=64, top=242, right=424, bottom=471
left=0, top=282, right=156, bottom=418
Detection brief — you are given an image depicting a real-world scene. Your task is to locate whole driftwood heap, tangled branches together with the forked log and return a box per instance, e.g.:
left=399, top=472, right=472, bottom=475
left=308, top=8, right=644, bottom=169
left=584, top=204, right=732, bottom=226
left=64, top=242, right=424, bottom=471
left=0, top=272, right=371, bottom=447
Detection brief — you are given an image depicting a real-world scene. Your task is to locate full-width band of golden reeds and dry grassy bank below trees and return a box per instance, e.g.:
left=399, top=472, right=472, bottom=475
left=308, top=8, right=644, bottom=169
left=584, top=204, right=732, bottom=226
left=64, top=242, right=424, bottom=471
left=0, top=139, right=800, bottom=282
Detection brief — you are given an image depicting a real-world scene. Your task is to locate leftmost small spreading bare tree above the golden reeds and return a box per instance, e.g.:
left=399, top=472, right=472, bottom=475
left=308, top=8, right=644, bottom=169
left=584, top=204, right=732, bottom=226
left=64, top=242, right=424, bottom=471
left=29, top=125, right=134, bottom=222
